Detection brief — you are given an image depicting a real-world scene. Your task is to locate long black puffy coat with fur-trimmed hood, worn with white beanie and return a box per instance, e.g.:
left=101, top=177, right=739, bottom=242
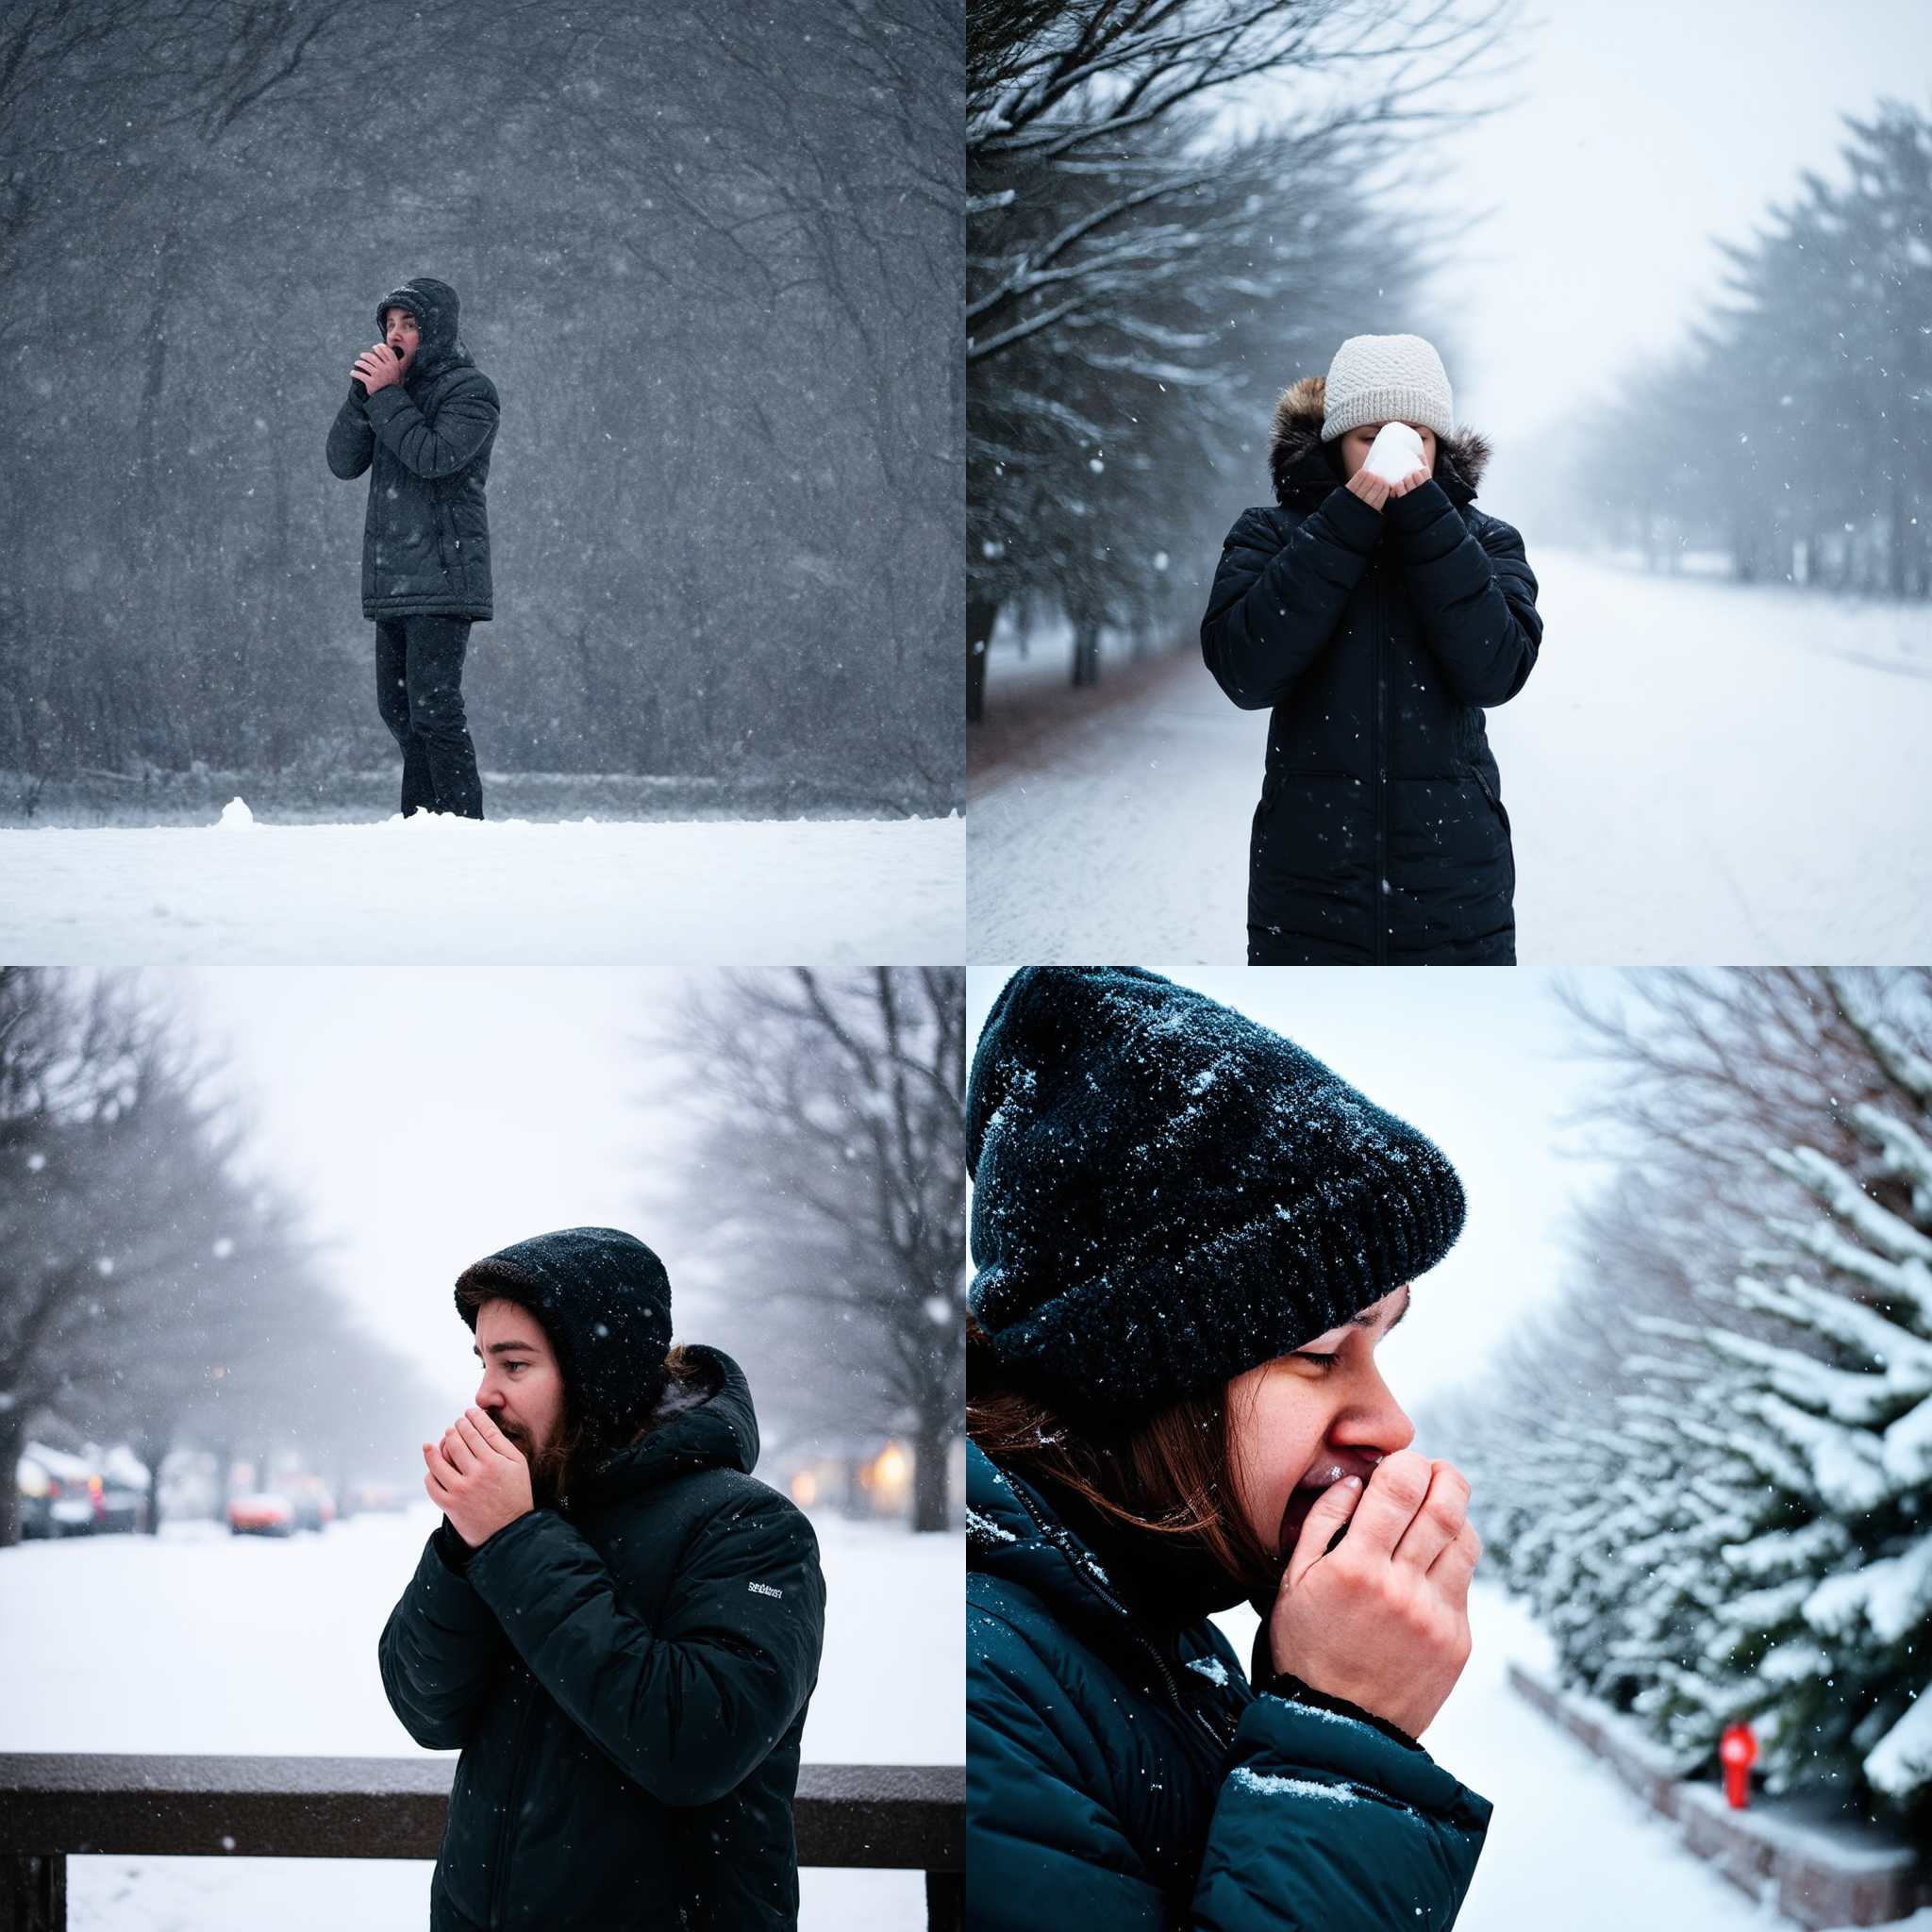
left=1202, top=376, right=1543, bottom=966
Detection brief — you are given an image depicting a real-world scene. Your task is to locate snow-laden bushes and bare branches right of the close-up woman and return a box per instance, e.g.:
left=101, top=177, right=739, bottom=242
left=1427, top=968, right=1932, bottom=1832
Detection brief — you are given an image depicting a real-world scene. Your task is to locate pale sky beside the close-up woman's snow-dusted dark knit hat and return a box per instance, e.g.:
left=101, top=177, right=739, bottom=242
left=966, top=960, right=1615, bottom=1407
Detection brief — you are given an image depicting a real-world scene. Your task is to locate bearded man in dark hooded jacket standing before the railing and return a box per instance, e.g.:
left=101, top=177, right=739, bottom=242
left=378, top=1226, right=824, bottom=1932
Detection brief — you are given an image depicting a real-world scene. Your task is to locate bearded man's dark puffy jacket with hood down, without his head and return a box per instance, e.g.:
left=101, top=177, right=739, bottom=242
left=378, top=1349, right=824, bottom=1932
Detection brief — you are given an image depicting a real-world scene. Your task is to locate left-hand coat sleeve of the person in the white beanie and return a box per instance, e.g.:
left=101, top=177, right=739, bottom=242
left=1202, top=485, right=1381, bottom=711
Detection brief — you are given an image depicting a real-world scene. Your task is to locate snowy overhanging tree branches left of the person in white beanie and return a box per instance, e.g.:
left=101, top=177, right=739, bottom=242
left=966, top=0, right=1507, bottom=719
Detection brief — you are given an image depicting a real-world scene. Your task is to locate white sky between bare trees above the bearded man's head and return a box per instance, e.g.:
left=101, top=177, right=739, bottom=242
left=149, top=966, right=730, bottom=1414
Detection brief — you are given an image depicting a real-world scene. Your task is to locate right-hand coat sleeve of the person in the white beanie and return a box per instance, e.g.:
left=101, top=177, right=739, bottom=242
left=1383, top=477, right=1543, bottom=706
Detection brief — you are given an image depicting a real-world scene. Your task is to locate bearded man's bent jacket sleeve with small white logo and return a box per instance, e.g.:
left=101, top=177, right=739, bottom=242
left=470, top=1491, right=824, bottom=1805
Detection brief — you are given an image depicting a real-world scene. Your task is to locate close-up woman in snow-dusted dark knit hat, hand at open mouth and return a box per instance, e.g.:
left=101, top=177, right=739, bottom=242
left=966, top=966, right=1491, bottom=1932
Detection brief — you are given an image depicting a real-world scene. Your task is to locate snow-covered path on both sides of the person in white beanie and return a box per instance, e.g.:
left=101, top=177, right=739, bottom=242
left=968, top=551, right=1932, bottom=964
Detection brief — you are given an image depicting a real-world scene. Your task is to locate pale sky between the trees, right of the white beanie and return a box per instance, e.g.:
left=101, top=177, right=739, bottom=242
left=1243, top=0, right=1932, bottom=506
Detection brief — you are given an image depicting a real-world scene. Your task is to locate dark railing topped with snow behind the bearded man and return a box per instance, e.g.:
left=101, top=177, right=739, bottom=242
left=0, top=1753, right=966, bottom=1932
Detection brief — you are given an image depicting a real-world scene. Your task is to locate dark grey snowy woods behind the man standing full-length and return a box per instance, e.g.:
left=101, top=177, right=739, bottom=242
left=0, top=0, right=964, bottom=809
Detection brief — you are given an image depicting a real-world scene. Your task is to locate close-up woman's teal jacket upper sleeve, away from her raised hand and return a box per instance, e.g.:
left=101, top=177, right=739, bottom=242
left=966, top=1604, right=1174, bottom=1932
